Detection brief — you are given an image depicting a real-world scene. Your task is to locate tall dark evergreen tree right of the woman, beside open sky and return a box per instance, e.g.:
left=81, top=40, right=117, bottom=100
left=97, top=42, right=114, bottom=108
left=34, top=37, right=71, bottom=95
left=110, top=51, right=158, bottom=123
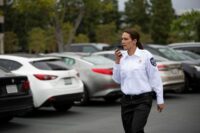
left=150, top=0, right=174, bottom=44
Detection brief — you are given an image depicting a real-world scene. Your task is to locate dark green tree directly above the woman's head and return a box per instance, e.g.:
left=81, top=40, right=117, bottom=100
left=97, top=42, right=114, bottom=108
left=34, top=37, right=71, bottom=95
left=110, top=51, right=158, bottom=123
left=125, top=0, right=150, bottom=33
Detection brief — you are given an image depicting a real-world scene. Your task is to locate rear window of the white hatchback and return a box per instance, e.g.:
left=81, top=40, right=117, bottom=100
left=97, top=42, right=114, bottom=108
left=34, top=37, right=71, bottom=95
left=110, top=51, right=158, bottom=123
left=31, top=59, right=69, bottom=70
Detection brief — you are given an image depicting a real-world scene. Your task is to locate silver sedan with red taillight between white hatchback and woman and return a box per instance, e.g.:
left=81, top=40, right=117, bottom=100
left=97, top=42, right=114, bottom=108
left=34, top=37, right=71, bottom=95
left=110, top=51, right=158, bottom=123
left=47, top=53, right=122, bottom=104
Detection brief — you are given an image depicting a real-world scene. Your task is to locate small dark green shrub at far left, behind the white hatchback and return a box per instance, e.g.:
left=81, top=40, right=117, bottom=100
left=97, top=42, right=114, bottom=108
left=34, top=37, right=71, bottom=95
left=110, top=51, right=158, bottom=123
left=4, top=32, right=19, bottom=53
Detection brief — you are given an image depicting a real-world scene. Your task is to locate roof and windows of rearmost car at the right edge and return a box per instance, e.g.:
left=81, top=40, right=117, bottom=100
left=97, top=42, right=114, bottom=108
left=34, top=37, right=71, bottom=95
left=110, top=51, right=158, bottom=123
left=168, top=42, right=200, bottom=55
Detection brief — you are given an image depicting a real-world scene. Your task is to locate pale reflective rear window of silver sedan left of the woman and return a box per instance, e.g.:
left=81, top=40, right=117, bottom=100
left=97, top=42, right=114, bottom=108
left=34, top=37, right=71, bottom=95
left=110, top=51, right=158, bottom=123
left=82, top=56, right=113, bottom=65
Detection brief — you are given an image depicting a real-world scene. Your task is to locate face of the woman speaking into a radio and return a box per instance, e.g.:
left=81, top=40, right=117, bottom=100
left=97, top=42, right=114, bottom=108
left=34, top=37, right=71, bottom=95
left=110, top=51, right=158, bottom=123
left=121, top=32, right=136, bottom=50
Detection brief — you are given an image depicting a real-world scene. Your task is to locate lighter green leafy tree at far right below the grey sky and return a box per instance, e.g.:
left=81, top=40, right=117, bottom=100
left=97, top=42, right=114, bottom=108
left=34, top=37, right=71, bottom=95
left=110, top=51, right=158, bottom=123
left=170, top=11, right=200, bottom=42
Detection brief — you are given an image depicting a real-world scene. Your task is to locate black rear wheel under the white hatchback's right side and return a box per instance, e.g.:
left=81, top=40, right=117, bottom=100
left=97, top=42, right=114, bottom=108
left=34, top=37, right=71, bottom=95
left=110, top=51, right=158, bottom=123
left=53, top=103, right=73, bottom=112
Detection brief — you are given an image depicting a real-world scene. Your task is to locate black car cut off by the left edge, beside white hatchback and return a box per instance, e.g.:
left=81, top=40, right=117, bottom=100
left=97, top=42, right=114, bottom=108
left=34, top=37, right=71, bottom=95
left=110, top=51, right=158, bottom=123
left=0, top=67, right=33, bottom=123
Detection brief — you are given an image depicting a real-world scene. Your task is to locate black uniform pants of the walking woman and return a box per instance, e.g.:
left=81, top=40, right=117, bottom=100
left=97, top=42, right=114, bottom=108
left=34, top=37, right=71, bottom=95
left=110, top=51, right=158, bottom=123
left=121, top=93, right=153, bottom=133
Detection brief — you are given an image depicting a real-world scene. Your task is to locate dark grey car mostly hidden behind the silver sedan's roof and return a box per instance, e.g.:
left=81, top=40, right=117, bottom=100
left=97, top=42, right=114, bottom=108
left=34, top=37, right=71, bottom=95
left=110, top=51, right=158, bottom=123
left=64, top=43, right=109, bottom=53
